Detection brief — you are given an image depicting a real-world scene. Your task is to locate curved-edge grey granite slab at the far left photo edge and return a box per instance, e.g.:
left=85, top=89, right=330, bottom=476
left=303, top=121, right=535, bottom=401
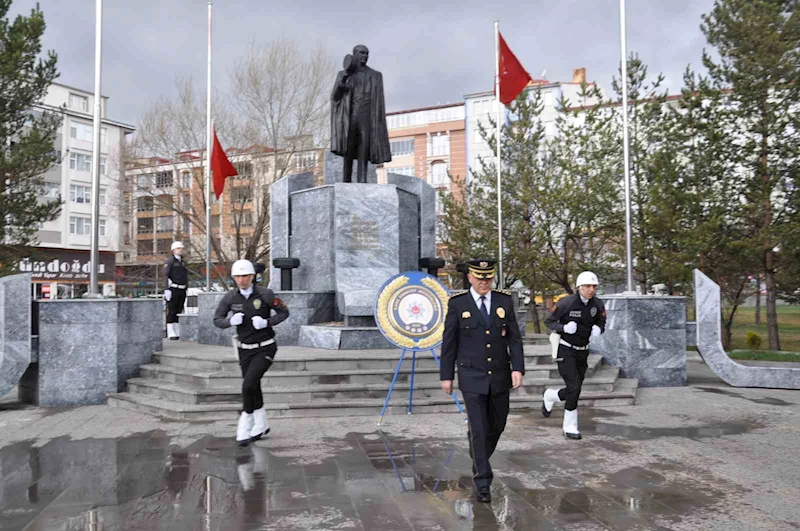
left=0, top=273, right=32, bottom=397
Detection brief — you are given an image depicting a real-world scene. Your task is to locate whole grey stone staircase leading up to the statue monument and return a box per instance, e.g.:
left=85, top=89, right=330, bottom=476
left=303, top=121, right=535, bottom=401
left=108, top=341, right=638, bottom=421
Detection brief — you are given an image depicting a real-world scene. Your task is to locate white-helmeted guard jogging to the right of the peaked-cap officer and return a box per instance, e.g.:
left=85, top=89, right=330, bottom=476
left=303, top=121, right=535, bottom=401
left=542, top=271, right=606, bottom=439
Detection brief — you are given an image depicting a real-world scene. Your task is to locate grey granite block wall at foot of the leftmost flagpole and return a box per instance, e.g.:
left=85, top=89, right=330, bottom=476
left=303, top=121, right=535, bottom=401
left=28, top=299, right=164, bottom=406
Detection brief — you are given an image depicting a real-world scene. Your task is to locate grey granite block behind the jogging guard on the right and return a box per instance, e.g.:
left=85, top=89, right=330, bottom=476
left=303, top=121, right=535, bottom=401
left=590, top=295, right=686, bottom=387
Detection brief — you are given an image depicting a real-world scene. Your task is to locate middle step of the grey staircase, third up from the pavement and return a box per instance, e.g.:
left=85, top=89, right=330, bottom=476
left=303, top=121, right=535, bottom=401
left=140, top=356, right=608, bottom=388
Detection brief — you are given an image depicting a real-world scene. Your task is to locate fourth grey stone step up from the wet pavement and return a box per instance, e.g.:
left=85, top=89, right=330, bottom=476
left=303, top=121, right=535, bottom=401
left=153, top=350, right=601, bottom=374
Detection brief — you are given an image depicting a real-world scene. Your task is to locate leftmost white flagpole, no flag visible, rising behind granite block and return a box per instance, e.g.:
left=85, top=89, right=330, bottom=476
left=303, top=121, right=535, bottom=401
left=89, top=0, right=103, bottom=296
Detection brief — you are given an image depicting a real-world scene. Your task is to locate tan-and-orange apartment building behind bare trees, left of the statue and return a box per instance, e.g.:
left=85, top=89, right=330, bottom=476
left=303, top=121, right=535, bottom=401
left=119, top=146, right=323, bottom=295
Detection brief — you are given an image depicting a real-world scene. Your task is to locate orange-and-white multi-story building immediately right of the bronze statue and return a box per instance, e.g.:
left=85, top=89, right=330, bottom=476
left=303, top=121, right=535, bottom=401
left=378, top=103, right=467, bottom=254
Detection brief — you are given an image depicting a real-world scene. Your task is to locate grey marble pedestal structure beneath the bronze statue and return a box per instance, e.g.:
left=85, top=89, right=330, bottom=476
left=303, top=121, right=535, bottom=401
left=271, top=170, right=436, bottom=348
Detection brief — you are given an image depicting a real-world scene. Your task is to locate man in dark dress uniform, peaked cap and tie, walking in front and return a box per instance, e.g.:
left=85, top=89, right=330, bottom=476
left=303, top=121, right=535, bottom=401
left=439, top=260, right=525, bottom=502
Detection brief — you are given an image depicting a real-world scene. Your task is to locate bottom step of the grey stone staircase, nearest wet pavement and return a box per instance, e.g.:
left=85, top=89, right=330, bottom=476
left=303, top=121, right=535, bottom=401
left=108, top=390, right=636, bottom=422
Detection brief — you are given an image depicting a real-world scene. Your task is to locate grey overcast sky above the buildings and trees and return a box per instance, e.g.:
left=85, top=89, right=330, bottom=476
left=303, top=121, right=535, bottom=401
left=12, top=0, right=713, bottom=125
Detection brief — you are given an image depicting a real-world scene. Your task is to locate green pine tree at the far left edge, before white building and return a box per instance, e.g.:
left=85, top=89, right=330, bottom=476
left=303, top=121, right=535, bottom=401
left=0, top=0, right=61, bottom=274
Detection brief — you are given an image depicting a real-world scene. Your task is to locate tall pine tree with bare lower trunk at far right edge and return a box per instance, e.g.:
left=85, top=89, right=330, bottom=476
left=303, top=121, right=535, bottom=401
left=701, top=0, right=800, bottom=350
